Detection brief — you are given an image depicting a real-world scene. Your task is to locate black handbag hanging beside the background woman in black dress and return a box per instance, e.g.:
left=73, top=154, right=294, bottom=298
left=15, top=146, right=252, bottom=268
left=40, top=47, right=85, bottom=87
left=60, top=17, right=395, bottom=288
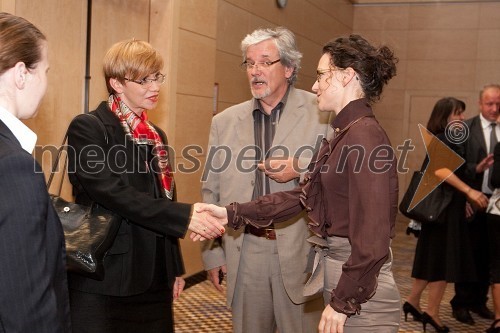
left=399, top=171, right=453, bottom=223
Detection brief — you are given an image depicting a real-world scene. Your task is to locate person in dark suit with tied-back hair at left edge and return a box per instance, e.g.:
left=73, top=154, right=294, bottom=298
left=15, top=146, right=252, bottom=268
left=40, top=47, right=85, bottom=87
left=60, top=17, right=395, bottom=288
left=0, top=13, right=71, bottom=333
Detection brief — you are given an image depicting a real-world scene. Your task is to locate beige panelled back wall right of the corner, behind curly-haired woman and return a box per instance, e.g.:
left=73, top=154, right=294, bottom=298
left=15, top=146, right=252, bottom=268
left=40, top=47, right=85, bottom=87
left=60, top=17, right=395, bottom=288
left=354, top=1, right=500, bottom=192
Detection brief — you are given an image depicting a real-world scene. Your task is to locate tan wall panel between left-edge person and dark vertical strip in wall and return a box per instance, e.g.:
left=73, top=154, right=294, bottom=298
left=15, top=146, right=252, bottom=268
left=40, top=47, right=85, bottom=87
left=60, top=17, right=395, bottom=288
left=13, top=0, right=86, bottom=188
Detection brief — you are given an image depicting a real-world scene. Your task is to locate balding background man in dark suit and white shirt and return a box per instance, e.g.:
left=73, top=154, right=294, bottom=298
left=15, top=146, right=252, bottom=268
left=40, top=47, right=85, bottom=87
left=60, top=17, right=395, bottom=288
left=450, top=85, right=500, bottom=325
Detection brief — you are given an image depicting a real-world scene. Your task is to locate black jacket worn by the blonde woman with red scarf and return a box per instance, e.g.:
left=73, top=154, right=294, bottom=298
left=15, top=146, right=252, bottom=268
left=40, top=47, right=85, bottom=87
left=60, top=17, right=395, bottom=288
left=68, top=102, right=191, bottom=296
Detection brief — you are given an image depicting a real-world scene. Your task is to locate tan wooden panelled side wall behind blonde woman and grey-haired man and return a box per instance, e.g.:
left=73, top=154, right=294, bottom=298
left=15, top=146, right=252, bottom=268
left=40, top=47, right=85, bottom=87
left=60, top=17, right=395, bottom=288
left=0, top=0, right=353, bottom=275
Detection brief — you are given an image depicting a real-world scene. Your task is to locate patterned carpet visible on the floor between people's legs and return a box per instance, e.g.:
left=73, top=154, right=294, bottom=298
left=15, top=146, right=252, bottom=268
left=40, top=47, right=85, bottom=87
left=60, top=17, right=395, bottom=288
left=174, top=217, right=493, bottom=333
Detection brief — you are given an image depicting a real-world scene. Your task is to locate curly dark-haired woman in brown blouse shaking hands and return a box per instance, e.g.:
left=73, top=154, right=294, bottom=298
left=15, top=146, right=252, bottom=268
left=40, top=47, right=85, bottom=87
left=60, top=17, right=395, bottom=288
left=198, top=35, right=400, bottom=333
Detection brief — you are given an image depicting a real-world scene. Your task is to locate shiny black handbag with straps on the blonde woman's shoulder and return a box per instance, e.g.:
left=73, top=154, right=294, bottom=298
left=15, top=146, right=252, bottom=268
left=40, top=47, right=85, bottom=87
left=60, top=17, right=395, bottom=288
left=47, top=115, right=122, bottom=281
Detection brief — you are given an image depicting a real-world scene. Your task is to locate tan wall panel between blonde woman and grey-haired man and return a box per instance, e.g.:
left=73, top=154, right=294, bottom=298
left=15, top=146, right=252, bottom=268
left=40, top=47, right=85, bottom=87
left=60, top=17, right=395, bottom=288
left=171, top=0, right=217, bottom=275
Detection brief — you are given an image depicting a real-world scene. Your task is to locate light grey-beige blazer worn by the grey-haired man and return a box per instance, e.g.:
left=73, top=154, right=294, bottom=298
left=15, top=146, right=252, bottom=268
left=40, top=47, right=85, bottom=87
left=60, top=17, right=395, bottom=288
left=202, top=87, right=329, bottom=306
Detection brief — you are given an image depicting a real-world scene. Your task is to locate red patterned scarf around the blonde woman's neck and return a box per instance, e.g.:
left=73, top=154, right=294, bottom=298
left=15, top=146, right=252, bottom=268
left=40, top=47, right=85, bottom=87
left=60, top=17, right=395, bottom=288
left=108, top=94, right=174, bottom=200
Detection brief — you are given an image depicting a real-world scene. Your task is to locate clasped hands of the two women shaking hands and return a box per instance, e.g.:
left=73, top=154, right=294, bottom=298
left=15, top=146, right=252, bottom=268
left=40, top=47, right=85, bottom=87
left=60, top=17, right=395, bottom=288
left=188, top=203, right=227, bottom=241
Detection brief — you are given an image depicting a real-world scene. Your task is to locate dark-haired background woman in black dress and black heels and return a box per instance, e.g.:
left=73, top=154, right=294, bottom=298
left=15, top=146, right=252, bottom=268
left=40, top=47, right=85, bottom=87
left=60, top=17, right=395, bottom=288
left=403, top=97, right=487, bottom=332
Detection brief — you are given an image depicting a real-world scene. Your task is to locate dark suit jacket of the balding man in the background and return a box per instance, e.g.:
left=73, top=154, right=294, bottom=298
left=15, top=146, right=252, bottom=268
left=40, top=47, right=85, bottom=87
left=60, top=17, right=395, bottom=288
left=464, top=115, right=488, bottom=191
